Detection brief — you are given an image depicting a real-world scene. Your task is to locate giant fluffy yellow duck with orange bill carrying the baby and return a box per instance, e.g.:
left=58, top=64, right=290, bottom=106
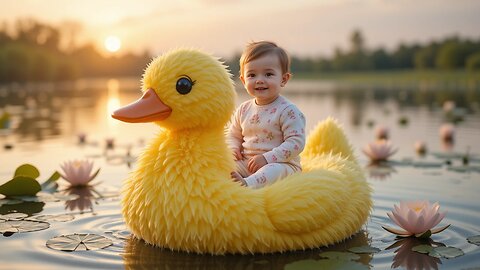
left=112, top=49, right=372, bottom=254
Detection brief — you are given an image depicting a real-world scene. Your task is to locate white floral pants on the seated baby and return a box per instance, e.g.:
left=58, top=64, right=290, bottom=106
left=235, top=159, right=301, bottom=188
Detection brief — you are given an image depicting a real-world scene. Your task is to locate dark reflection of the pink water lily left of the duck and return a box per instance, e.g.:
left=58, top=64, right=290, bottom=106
left=64, top=186, right=96, bottom=214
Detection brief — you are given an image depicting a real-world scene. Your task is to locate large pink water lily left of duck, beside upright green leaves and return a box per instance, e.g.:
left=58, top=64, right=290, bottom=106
left=60, top=160, right=100, bottom=186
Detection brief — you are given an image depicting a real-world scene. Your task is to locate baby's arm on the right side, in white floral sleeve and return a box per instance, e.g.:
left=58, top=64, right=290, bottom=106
left=263, top=105, right=305, bottom=163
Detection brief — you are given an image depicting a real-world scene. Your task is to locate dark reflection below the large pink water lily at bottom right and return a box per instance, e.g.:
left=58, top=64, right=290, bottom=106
left=386, top=237, right=444, bottom=270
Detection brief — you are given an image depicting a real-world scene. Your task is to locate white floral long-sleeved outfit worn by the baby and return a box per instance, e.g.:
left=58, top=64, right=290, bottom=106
left=227, top=96, right=305, bottom=188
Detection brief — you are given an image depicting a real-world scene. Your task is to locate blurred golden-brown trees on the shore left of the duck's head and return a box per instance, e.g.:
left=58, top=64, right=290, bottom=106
left=0, top=19, right=151, bottom=83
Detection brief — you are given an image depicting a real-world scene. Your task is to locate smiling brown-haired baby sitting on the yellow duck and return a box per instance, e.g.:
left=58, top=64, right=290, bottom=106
left=227, top=41, right=305, bottom=188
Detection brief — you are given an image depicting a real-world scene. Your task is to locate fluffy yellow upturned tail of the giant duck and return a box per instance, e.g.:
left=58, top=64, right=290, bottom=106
left=302, top=117, right=355, bottom=161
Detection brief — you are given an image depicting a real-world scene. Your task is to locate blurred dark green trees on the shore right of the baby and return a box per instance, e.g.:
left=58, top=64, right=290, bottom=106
left=292, top=30, right=480, bottom=73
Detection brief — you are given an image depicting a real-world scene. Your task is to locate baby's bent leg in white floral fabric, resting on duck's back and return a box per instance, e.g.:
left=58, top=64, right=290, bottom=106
left=245, top=163, right=295, bottom=188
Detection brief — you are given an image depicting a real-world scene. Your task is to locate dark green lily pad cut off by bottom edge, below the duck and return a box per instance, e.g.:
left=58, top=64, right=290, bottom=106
left=284, top=259, right=369, bottom=270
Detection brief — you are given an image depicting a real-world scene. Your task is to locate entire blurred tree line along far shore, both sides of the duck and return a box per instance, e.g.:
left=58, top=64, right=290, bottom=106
left=0, top=19, right=480, bottom=83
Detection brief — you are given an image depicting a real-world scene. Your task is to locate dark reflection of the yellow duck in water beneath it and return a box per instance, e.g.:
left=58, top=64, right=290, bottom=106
left=122, top=232, right=372, bottom=270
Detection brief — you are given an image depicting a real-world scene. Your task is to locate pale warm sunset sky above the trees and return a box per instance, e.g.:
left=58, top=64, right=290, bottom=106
left=0, top=0, right=480, bottom=57
